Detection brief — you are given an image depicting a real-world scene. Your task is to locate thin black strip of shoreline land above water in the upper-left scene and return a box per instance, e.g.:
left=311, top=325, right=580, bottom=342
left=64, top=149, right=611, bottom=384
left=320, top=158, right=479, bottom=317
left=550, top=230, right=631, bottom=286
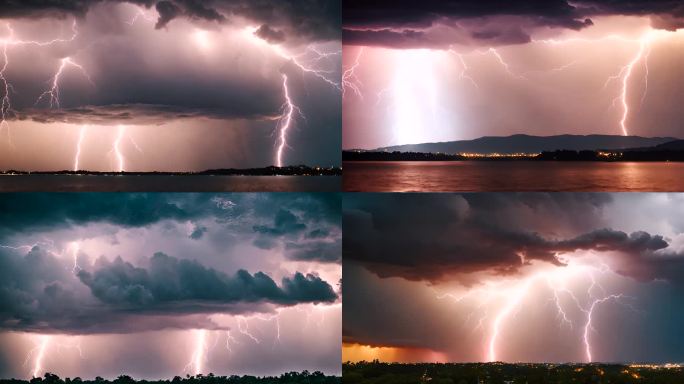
left=0, top=165, right=342, bottom=176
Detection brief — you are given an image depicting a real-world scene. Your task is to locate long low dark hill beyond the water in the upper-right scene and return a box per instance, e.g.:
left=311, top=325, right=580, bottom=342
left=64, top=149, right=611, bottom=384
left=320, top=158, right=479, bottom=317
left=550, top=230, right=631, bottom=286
left=377, top=135, right=684, bottom=153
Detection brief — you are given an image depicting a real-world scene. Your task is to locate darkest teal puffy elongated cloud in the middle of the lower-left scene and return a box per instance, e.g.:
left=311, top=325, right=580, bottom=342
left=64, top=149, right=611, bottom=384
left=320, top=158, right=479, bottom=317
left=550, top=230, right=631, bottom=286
left=78, top=253, right=337, bottom=308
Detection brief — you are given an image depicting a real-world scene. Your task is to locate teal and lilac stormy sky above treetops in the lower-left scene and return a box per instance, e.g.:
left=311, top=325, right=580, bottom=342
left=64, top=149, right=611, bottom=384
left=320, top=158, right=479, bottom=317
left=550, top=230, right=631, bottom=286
left=0, top=193, right=342, bottom=379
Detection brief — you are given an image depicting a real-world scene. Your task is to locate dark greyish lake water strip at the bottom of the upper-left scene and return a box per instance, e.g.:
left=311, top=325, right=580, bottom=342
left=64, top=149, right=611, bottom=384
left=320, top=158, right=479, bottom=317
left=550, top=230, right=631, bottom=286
left=0, top=175, right=342, bottom=192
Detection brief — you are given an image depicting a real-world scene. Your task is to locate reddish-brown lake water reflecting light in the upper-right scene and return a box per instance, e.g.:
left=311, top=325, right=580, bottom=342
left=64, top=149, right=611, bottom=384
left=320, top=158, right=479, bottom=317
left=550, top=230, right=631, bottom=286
left=343, top=161, right=684, bottom=192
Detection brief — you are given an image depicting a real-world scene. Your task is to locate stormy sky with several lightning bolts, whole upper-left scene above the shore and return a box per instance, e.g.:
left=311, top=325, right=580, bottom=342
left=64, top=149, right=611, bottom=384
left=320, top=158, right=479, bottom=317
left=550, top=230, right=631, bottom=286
left=0, top=0, right=342, bottom=171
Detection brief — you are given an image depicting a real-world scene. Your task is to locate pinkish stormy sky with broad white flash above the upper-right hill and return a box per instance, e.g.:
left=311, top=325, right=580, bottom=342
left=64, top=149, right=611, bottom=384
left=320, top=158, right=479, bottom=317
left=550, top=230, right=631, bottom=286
left=342, top=0, right=684, bottom=149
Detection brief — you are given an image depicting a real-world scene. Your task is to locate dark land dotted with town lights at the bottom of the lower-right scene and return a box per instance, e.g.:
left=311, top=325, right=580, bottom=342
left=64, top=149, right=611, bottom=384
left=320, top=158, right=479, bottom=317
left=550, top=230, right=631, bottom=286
left=342, top=361, right=684, bottom=384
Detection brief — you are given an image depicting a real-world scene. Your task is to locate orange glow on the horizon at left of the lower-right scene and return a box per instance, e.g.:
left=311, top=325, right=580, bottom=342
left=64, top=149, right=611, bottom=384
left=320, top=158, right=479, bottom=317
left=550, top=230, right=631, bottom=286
left=342, top=343, right=449, bottom=363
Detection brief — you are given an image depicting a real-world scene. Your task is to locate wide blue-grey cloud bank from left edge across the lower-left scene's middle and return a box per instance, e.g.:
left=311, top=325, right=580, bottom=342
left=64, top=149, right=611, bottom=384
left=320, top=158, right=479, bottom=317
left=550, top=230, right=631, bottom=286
left=0, top=247, right=338, bottom=333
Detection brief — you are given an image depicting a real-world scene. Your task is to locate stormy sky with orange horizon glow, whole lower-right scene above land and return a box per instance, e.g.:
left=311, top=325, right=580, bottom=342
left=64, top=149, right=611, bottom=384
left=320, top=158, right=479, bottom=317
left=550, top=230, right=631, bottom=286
left=342, top=193, right=684, bottom=363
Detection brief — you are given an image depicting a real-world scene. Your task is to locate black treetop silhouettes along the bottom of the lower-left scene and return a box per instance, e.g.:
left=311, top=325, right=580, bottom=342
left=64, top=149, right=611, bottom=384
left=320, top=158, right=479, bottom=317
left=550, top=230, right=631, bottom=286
left=0, top=371, right=341, bottom=384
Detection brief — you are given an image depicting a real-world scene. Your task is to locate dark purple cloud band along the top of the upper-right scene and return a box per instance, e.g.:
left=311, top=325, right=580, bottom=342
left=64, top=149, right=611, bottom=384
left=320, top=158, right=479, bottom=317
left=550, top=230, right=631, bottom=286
left=343, top=0, right=684, bottom=48
